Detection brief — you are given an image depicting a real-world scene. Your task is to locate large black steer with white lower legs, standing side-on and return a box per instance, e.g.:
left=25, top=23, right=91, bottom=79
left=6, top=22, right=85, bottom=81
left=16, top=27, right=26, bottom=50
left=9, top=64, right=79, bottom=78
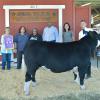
left=24, top=31, right=100, bottom=95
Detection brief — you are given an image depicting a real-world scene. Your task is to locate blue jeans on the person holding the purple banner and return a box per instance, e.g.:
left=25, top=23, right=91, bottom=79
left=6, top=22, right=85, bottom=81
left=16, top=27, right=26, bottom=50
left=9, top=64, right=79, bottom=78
left=2, top=53, right=11, bottom=70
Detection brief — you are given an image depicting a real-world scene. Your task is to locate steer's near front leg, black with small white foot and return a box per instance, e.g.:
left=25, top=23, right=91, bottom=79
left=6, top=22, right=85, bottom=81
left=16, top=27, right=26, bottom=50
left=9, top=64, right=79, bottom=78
left=78, top=67, right=86, bottom=89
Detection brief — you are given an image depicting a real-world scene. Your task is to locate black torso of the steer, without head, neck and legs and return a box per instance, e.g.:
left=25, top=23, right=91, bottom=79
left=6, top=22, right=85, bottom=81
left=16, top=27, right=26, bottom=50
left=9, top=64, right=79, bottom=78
left=24, top=41, right=89, bottom=72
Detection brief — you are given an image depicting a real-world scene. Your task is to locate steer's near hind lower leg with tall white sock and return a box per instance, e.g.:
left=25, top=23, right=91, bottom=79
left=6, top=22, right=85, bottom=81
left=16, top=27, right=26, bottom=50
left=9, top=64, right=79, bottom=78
left=24, top=72, right=32, bottom=95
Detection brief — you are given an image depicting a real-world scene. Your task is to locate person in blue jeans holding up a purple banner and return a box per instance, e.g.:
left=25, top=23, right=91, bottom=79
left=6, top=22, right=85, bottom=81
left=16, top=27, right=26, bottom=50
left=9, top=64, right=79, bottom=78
left=1, top=27, right=13, bottom=70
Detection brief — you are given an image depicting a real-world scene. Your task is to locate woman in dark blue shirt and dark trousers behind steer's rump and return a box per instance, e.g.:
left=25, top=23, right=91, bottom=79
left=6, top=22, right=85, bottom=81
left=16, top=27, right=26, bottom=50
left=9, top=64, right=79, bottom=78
left=14, top=26, right=29, bottom=69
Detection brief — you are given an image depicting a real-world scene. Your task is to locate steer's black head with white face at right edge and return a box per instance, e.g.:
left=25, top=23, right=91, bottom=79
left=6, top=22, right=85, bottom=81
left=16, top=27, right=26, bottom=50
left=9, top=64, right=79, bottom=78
left=88, top=31, right=100, bottom=47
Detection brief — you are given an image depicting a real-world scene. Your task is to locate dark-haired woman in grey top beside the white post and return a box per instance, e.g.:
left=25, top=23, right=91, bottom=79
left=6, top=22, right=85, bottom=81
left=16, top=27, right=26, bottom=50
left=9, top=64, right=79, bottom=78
left=63, top=23, right=73, bottom=42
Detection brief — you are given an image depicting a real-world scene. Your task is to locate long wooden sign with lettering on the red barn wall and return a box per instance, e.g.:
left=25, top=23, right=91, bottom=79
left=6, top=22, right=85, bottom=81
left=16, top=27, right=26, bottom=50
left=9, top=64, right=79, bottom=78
left=10, top=10, right=58, bottom=23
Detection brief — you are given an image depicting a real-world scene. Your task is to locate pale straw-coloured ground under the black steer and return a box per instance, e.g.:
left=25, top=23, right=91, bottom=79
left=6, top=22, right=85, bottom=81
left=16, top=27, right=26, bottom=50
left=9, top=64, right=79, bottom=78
left=0, top=64, right=100, bottom=100
